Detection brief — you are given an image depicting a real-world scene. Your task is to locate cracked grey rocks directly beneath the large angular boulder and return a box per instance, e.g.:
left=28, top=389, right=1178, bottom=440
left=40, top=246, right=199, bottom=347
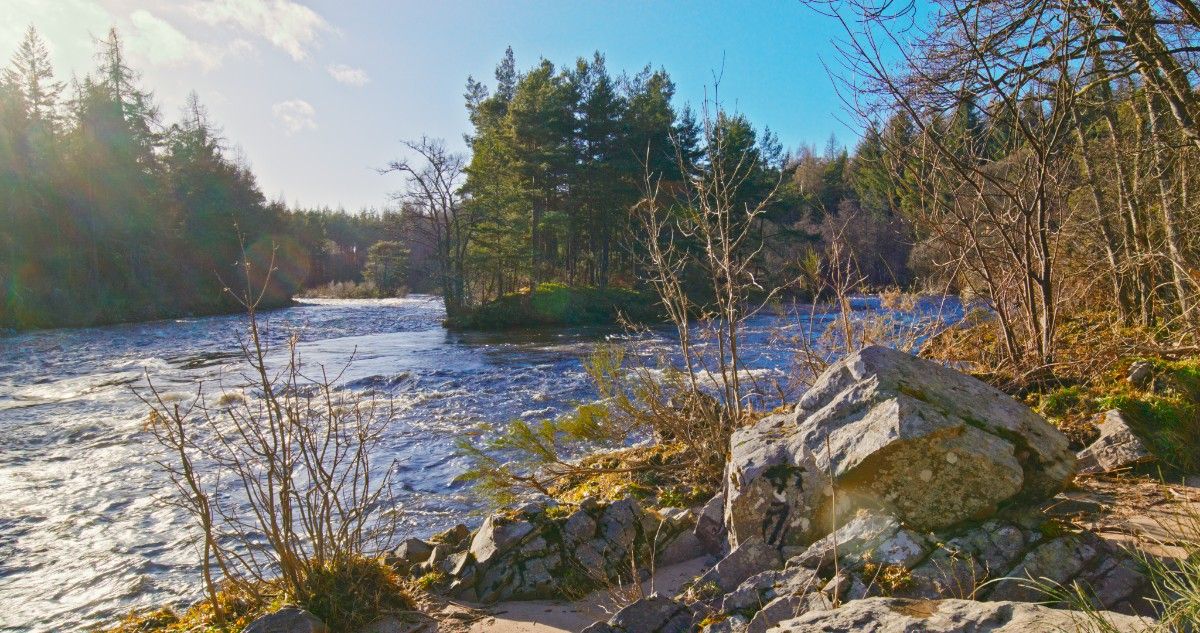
left=696, top=511, right=1147, bottom=631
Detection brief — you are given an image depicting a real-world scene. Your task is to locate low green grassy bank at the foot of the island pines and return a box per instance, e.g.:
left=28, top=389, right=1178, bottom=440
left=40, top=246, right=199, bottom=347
left=446, top=283, right=661, bottom=330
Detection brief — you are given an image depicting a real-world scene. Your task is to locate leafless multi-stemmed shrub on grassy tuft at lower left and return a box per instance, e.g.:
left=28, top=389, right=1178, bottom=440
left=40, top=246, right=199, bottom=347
left=139, top=274, right=403, bottom=628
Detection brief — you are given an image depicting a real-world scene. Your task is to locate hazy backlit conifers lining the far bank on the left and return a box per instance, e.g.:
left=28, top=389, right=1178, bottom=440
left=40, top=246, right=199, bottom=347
left=0, top=26, right=410, bottom=327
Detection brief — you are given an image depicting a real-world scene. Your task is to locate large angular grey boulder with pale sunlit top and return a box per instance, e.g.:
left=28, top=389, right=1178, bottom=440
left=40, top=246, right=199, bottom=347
left=725, top=346, right=1075, bottom=548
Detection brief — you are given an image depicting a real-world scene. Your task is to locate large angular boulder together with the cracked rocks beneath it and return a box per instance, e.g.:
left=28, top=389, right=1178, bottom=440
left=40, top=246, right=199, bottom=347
left=667, top=348, right=1146, bottom=633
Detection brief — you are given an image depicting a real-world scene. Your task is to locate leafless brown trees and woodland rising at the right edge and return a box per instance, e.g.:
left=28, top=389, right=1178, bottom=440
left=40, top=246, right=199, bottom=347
left=809, top=0, right=1200, bottom=372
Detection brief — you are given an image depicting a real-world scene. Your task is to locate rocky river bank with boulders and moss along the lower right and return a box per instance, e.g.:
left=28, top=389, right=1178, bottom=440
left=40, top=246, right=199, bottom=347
left=112, top=338, right=1200, bottom=633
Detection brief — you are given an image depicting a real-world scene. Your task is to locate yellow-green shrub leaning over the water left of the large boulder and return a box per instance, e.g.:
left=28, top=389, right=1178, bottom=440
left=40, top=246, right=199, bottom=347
left=458, top=345, right=736, bottom=504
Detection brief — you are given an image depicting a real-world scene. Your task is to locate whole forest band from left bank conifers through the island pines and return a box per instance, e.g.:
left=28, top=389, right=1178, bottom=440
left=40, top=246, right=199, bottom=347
left=0, top=28, right=910, bottom=328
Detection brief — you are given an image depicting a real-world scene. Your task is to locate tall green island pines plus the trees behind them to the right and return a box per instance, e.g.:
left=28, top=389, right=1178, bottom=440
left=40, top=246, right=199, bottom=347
left=385, top=49, right=911, bottom=315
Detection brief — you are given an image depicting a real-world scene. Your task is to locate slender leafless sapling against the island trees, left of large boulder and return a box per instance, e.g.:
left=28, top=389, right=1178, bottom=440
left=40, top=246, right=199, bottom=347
left=634, top=90, right=788, bottom=423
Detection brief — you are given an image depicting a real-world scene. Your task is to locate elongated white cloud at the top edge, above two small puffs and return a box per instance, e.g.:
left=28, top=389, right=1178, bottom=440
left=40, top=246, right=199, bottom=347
left=188, top=0, right=332, bottom=61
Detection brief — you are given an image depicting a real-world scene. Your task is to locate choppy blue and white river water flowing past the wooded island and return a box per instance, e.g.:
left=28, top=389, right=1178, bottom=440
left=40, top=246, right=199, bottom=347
left=0, top=296, right=958, bottom=632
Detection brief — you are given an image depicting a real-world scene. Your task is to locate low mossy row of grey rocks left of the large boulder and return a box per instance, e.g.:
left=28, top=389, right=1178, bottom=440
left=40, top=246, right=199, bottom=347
left=421, top=499, right=698, bottom=603
